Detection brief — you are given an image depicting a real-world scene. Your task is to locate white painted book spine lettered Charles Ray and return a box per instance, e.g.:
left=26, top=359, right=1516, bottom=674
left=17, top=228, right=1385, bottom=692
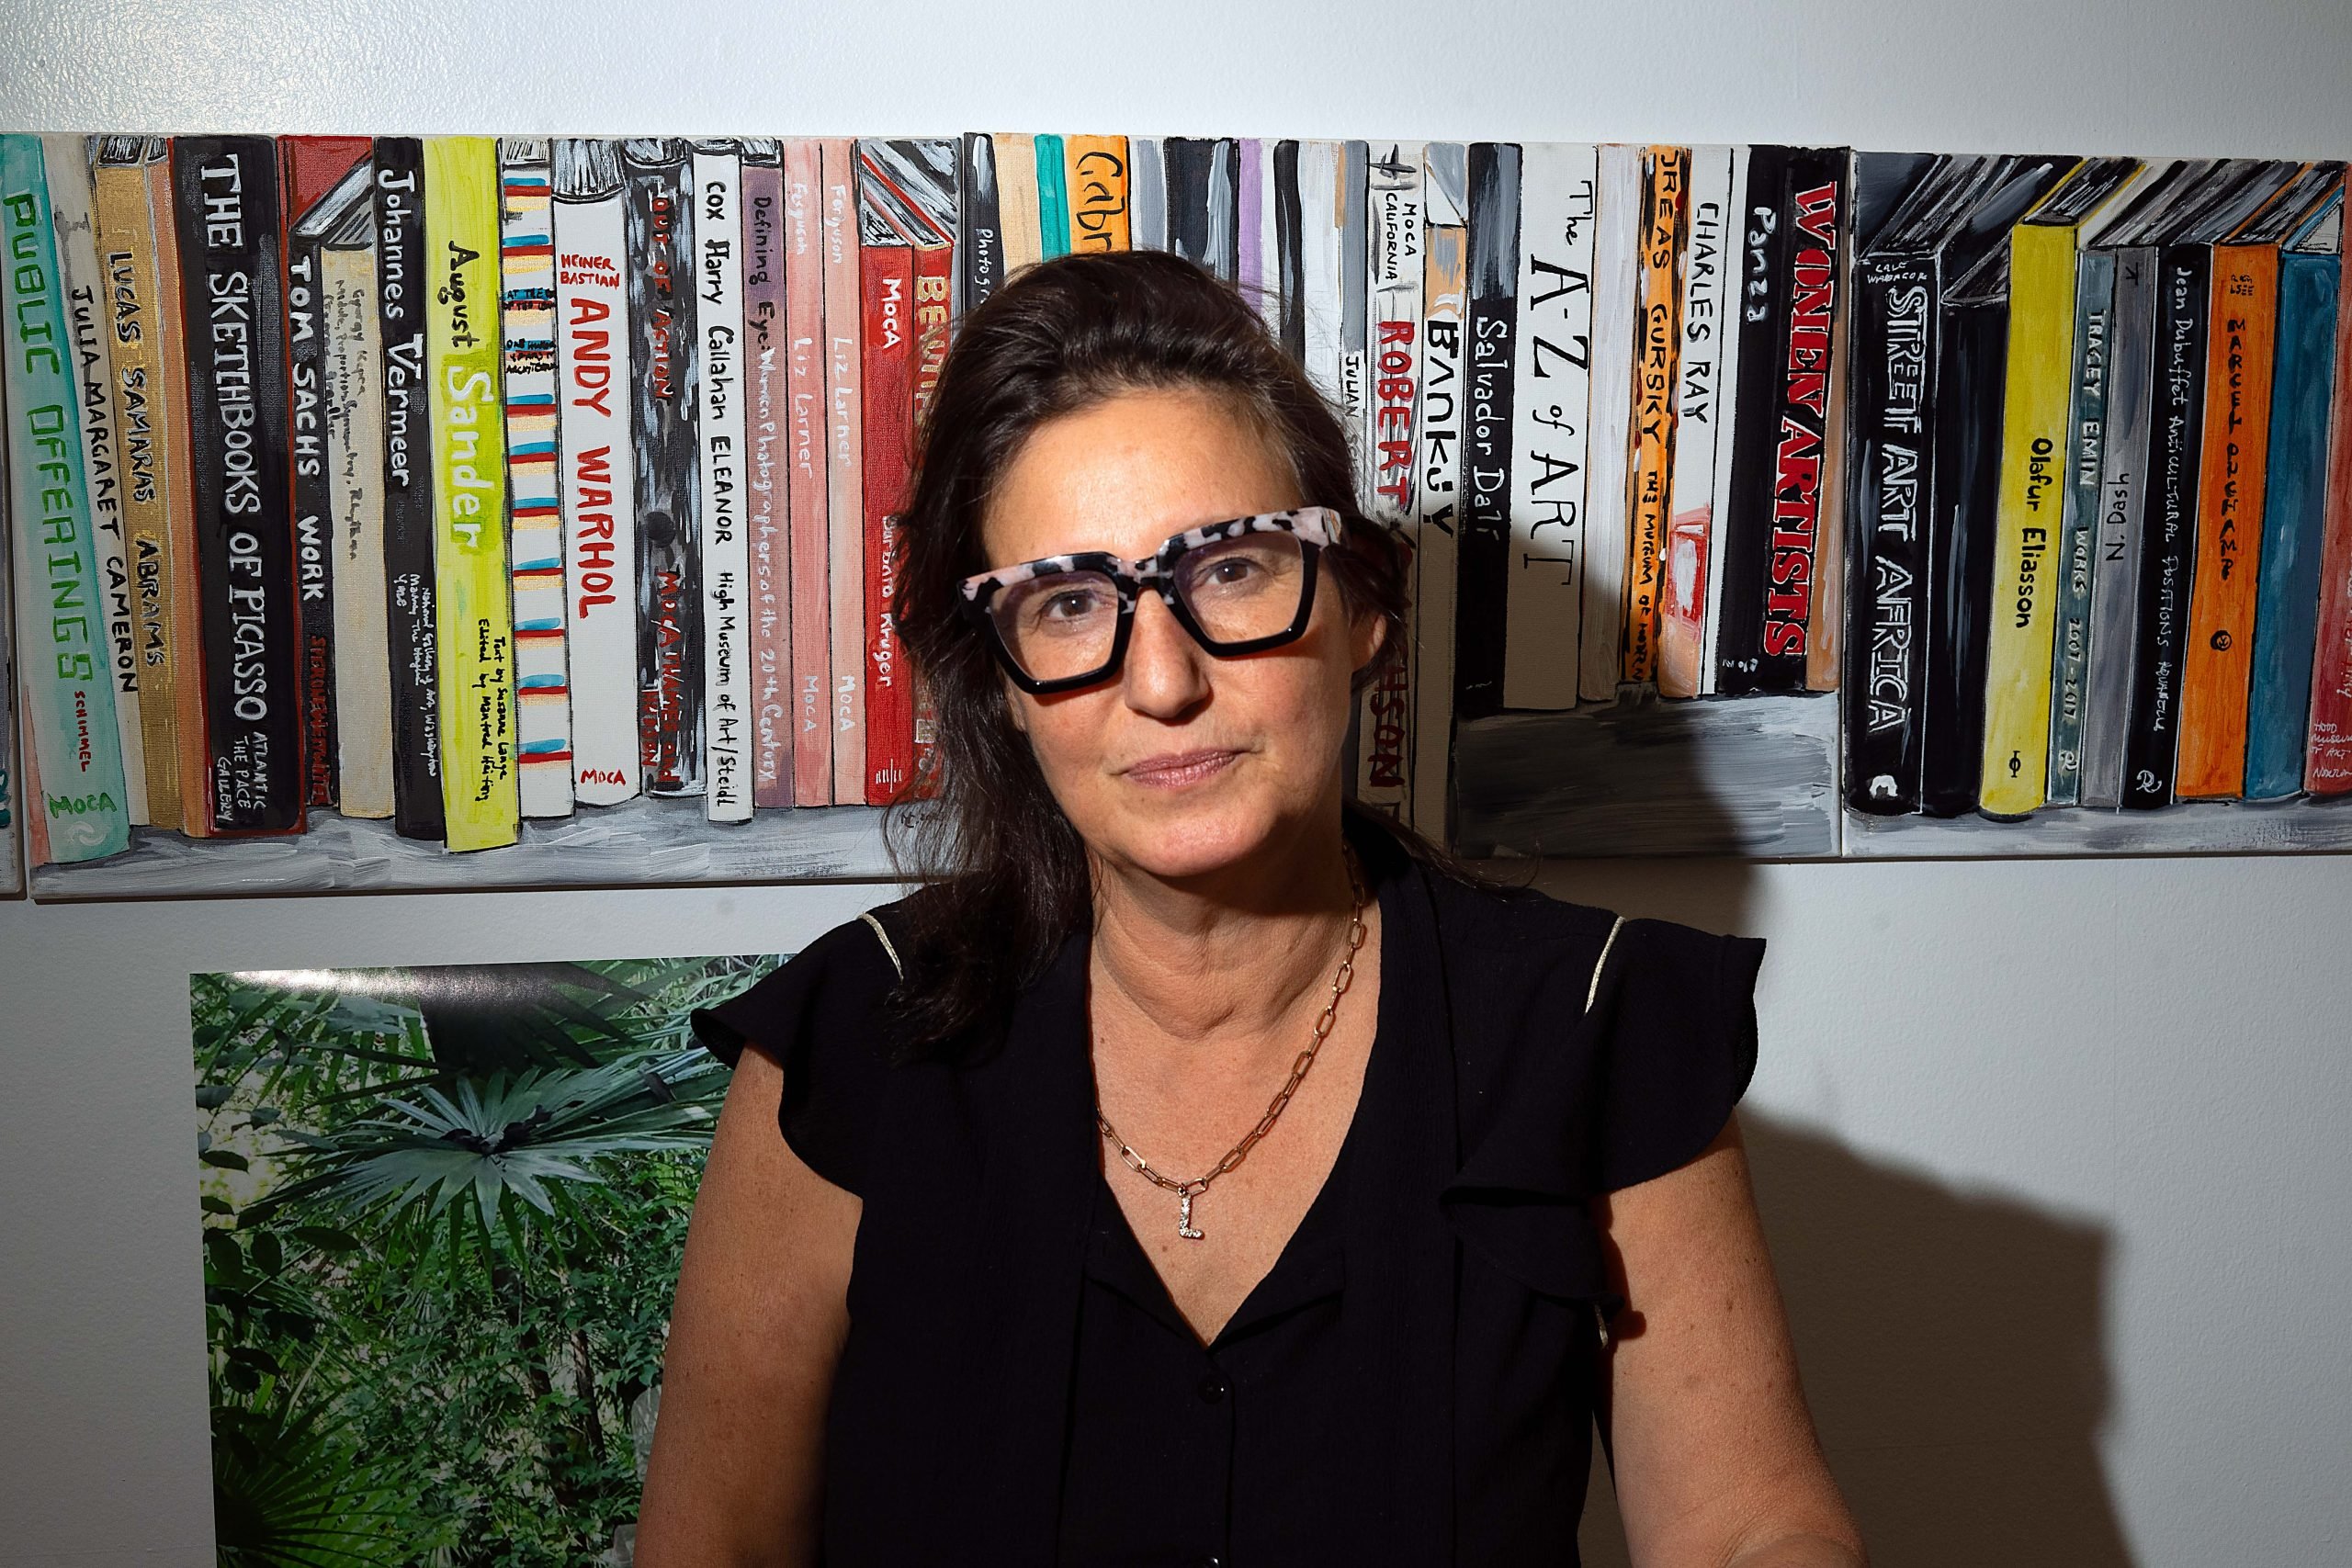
left=1665, top=146, right=1738, bottom=700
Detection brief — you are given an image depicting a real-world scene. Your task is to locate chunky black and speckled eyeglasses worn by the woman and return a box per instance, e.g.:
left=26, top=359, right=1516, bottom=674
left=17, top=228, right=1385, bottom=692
left=965, top=505, right=1340, bottom=696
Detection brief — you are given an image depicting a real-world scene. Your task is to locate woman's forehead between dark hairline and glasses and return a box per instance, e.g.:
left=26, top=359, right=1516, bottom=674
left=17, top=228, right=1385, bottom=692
left=981, top=392, right=1303, bottom=564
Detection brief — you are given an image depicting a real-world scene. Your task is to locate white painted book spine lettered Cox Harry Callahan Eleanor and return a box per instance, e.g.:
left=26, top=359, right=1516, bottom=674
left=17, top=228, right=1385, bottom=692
left=692, top=151, right=752, bottom=823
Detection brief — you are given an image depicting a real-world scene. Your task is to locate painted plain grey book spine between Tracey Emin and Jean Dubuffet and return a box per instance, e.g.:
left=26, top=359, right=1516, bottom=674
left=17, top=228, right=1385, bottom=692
left=2082, top=247, right=2157, bottom=811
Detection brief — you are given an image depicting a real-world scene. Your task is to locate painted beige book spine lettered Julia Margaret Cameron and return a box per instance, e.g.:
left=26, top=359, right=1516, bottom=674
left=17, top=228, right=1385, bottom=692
left=42, top=136, right=155, bottom=828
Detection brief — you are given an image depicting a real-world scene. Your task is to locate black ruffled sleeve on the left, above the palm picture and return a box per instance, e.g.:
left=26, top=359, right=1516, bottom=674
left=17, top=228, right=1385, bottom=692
left=692, top=912, right=899, bottom=1194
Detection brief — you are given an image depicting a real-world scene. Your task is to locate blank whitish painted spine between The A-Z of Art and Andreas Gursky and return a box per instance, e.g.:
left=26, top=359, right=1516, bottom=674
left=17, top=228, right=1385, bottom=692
left=1571, top=143, right=1642, bottom=707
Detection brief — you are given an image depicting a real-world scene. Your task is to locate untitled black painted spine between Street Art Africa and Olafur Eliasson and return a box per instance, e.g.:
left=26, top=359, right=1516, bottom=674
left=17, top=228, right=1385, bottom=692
left=1919, top=291, right=2008, bottom=816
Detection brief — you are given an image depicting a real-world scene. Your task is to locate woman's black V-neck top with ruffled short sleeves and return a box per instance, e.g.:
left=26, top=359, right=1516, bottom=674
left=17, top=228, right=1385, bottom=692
left=696, top=823, right=1764, bottom=1568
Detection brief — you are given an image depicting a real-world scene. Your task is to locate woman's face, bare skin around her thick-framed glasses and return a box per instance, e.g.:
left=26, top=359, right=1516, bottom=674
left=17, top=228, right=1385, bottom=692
left=981, top=390, right=1387, bottom=879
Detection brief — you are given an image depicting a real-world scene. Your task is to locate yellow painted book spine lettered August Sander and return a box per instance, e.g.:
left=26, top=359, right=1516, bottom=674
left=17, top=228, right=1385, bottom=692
left=425, top=136, right=522, bottom=849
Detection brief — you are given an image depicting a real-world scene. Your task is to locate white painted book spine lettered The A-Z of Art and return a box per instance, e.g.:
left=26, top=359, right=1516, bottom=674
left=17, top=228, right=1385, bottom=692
left=1505, top=143, right=1599, bottom=707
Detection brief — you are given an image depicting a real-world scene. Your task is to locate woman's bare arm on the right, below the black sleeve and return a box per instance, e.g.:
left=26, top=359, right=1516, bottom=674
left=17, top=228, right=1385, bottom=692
left=1595, top=1119, right=1865, bottom=1568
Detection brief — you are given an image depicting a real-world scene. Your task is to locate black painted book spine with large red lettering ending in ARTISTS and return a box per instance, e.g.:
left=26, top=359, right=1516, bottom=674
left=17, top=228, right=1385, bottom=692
left=1755, top=148, right=1851, bottom=691
